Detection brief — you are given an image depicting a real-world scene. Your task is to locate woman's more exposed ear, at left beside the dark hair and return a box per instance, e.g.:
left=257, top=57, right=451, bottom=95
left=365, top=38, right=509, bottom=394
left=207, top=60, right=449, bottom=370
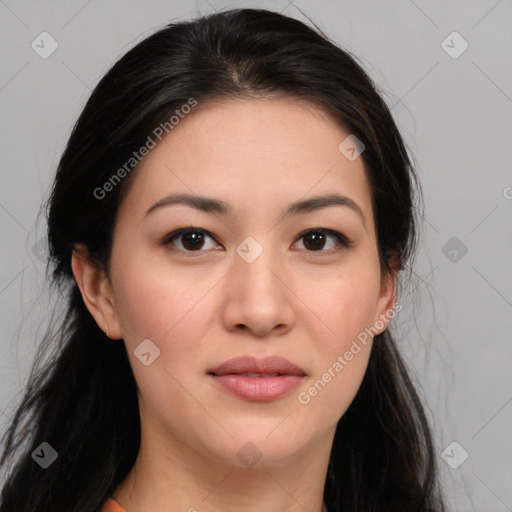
left=71, top=244, right=122, bottom=339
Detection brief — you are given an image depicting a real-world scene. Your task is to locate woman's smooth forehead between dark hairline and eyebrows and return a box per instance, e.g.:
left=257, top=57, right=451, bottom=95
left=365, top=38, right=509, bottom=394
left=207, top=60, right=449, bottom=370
left=117, top=98, right=371, bottom=224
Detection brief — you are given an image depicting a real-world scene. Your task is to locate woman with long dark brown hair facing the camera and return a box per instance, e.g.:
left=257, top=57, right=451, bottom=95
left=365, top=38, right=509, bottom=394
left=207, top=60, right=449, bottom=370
left=0, top=9, right=444, bottom=512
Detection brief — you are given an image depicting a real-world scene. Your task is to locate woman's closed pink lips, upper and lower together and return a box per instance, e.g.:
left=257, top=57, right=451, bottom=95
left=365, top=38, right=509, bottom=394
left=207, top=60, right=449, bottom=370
left=208, top=356, right=306, bottom=402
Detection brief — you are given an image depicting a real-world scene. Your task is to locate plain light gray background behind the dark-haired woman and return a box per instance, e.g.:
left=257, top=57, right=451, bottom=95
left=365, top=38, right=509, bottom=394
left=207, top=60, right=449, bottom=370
left=0, top=0, right=512, bottom=512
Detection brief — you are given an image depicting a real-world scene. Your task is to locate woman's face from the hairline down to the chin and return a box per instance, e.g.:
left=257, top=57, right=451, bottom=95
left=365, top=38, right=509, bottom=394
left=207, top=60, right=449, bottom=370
left=75, top=99, right=395, bottom=466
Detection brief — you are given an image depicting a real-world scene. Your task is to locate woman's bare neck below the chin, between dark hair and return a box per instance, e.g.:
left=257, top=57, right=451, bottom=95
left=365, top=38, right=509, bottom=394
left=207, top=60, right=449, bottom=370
left=113, top=420, right=334, bottom=512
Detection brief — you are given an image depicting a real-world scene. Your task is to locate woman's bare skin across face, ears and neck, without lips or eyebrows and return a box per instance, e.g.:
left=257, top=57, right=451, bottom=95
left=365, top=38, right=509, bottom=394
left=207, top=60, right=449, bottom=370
left=72, top=98, right=396, bottom=512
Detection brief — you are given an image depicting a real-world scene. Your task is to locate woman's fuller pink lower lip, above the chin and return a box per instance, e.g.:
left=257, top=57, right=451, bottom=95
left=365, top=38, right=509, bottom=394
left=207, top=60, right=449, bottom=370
left=211, top=374, right=304, bottom=402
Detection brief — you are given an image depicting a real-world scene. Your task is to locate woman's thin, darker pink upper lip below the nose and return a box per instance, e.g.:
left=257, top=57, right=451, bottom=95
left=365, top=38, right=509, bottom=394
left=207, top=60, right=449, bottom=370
left=208, top=356, right=306, bottom=375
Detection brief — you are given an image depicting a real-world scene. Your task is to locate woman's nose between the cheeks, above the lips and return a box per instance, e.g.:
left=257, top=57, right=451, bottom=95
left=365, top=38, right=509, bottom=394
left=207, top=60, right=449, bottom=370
left=223, top=245, right=295, bottom=338
